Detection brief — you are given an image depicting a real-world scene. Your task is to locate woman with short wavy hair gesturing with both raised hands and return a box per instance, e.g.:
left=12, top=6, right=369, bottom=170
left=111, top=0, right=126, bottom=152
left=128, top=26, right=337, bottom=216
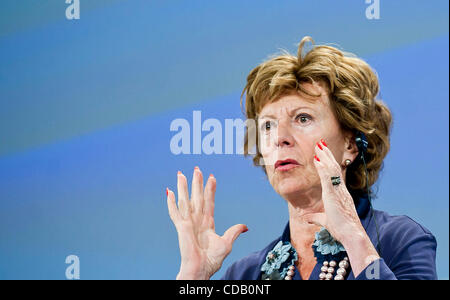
left=166, top=37, right=436, bottom=280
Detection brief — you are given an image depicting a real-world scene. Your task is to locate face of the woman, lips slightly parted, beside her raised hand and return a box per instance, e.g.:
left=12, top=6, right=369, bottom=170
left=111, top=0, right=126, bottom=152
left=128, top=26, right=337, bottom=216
left=258, top=83, right=356, bottom=196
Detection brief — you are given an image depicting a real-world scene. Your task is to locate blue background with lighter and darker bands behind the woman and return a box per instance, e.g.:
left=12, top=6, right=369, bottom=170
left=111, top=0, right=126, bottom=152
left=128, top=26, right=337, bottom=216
left=0, top=0, right=449, bottom=279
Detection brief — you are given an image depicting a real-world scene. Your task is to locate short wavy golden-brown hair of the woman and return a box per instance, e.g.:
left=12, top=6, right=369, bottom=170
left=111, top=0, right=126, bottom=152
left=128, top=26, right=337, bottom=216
left=241, top=36, right=392, bottom=196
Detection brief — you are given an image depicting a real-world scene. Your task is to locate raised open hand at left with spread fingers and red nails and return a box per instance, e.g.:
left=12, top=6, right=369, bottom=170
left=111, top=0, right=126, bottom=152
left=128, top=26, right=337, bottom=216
left=167, top=167, right=248, bottom=279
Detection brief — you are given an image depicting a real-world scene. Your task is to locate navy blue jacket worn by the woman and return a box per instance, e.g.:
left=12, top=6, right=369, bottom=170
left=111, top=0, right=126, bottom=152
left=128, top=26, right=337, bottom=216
left=221, top=197, right=437, bottom=280
